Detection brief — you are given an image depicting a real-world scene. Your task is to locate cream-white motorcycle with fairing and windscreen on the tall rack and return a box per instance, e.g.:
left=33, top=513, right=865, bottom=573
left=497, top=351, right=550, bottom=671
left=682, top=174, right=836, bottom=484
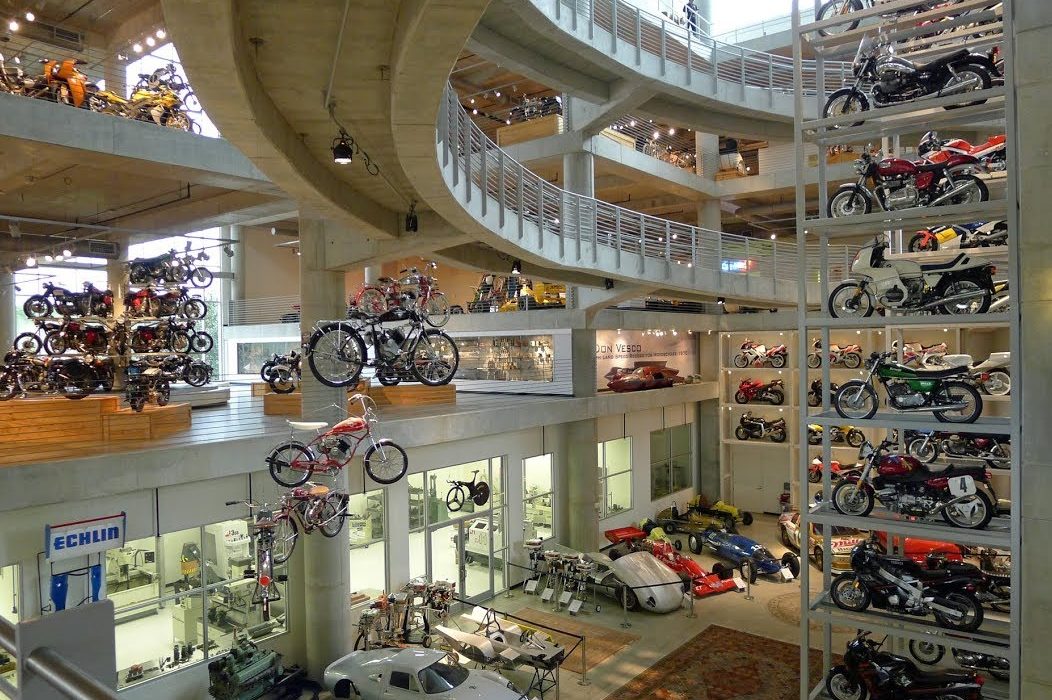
left=829, top=237, right=997, bottom=318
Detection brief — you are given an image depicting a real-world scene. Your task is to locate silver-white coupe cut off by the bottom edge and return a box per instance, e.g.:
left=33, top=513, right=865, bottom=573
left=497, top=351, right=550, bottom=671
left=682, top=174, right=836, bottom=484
left=325, top=648, right=525, bottom=700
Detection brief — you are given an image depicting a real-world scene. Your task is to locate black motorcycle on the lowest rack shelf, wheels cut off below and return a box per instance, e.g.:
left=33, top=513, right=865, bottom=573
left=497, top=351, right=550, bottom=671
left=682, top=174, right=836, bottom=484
left=826, top=632, right=984, bottom=700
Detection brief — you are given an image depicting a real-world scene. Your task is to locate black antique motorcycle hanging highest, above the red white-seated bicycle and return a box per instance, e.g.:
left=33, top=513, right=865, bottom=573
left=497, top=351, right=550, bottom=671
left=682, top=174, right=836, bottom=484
left=306, top=308, right=460, bottom=386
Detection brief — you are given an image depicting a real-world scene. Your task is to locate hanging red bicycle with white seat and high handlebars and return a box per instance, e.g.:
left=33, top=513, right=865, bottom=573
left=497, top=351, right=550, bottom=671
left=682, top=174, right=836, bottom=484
left=266, top=394, right=409, bottom=488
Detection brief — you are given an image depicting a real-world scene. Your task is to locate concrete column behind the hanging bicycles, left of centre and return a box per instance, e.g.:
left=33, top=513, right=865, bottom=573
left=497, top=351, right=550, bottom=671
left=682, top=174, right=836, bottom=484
left=300, top=217, right=361, bottom=678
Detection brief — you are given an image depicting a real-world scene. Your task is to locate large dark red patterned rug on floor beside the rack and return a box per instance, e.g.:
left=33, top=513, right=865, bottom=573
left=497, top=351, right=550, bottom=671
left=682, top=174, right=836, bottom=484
left=606, top=624, right=824, bottom=700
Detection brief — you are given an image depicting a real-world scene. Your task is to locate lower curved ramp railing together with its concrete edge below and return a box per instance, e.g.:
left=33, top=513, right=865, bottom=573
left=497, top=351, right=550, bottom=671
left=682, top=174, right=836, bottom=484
left=437, top=87, right=853, bottom=305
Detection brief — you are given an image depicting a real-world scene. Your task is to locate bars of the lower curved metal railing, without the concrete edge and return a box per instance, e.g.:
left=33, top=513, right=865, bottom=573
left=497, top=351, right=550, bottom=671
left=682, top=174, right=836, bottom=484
left=437, top=86, right=853, bottom=294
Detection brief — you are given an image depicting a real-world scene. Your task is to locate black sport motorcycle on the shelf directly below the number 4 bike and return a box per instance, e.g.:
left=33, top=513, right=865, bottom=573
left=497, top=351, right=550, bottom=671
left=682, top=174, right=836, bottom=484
left=829, top=536, right=983, bottom=632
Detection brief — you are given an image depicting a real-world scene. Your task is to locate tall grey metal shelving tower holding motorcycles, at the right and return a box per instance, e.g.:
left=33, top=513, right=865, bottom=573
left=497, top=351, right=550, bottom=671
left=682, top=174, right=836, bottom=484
left=790, top=0, right=1024, bottom=700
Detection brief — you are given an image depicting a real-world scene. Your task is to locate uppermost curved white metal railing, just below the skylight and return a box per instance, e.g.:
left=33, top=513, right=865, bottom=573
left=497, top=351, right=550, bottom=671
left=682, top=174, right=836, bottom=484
left=530, top=0, right=853, bottom=94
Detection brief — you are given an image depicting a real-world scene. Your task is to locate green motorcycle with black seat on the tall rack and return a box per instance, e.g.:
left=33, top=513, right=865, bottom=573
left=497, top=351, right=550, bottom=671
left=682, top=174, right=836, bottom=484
left=833, top=351, right=983, bottom=423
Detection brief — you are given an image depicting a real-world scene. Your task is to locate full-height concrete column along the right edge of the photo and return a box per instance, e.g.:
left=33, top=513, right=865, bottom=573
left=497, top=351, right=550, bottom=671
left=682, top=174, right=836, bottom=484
left=1009, top=2, right=1052, bottom=698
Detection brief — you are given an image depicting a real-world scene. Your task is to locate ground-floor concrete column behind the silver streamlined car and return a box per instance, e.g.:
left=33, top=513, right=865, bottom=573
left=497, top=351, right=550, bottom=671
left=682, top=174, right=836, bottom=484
left=544, top=419, right=600, bottom=552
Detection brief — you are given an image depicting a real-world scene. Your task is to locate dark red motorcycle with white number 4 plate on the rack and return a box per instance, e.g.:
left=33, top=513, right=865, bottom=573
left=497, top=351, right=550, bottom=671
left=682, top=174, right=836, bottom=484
left=832, top=433, right=997, bottom=529
